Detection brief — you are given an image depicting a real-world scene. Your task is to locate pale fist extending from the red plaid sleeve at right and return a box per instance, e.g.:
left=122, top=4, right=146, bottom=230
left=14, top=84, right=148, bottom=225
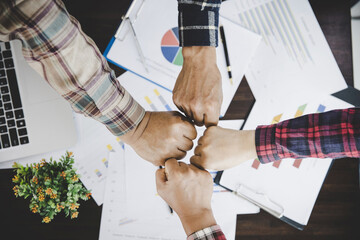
left=190, top=126, right=257, bottom=171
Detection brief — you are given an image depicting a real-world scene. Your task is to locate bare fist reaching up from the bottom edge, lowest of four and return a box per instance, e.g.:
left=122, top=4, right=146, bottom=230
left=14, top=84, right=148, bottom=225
left=156, top=159, right=216, bottom=235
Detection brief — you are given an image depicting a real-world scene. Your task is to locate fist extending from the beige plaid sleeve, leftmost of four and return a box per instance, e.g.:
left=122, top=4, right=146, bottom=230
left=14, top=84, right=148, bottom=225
left=121, top=112, right=197, bottom=166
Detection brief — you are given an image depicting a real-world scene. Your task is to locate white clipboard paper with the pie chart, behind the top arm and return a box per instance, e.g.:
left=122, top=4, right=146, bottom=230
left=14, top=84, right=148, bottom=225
left=107, top=0, right=261, bottom=116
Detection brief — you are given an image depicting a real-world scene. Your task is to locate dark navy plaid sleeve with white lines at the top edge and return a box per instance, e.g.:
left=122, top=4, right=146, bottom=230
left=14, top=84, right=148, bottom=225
left=178, top=0, right=221, bottom=47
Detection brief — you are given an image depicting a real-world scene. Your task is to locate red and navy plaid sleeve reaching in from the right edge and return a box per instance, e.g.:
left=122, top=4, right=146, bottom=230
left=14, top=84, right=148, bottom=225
left=255, top=108, right=360, bottom=163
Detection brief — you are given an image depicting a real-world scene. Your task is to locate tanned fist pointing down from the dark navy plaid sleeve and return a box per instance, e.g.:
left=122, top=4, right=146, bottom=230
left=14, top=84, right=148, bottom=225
left=173, top=46, right=222, bottom=127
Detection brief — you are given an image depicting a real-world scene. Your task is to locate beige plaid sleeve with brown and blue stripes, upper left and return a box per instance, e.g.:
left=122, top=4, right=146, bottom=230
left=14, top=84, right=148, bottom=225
left=0, top=0, right=145, bottom=136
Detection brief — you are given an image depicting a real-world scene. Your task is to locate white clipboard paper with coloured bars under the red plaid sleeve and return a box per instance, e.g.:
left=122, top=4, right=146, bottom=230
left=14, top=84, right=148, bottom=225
left=221, top=96, right=352, bottom=225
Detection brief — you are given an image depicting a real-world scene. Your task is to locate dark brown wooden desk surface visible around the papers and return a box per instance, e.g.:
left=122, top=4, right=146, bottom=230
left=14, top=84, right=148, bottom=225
left=0, top=0, right=360, bottom=240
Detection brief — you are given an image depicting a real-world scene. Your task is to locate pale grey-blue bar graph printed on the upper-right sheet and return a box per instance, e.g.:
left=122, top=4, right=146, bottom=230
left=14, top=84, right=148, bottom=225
left=238, top=0, right=312, bottom=67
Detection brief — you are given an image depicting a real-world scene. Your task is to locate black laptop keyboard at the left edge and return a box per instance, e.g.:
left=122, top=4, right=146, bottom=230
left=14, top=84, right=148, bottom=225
left=0, top=42, right=29, bottom=149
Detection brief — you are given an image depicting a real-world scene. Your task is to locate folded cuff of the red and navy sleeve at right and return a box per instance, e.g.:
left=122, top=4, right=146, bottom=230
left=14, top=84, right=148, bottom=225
left=255, top=124, right=280, bottom=163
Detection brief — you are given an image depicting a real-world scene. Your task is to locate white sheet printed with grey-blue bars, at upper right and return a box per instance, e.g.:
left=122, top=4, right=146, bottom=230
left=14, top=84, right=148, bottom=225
left=220, top=0, right=347, bottom=102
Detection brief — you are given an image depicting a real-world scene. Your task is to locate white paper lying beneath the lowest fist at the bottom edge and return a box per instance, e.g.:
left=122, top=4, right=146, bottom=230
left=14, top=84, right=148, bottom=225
left=100, top=142, right=258, bottom=240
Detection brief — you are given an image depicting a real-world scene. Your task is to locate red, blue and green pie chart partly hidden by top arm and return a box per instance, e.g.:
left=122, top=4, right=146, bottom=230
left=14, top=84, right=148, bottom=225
left=161, top=27, right=183, bottom=66
